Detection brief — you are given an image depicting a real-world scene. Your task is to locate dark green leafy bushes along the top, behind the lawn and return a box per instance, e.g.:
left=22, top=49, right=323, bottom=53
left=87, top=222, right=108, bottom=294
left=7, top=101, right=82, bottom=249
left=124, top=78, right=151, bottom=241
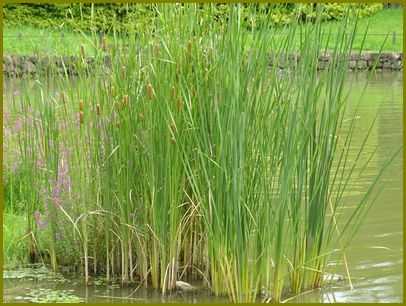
left=3, top=3, right=383, bottom=32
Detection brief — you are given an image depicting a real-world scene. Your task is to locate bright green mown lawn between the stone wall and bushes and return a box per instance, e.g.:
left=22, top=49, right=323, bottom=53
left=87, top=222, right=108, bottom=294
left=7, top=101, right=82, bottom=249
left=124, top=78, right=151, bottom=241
left=3, top=9, right=403, bottom=55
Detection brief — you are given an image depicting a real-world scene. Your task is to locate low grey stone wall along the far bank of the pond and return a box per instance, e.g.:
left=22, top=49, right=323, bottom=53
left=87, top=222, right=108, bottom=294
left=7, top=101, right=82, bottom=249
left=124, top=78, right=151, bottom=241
left=3, top=52, right=403, bottom=77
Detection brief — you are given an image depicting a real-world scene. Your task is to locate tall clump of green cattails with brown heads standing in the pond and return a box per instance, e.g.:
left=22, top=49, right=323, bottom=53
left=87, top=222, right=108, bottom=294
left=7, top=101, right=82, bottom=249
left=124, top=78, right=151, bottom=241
left=3, top=5, right=398, bottom=302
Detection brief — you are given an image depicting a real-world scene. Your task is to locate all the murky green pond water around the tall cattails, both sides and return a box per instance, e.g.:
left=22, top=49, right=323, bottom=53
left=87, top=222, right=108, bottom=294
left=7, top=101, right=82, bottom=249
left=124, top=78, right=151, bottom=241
left=3, top=72, right=403, bottom=303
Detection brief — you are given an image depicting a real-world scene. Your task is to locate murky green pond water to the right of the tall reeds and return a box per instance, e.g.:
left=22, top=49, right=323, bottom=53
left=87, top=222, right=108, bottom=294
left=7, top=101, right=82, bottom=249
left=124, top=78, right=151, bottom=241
left=318, top=73, right=403, bottom=303
